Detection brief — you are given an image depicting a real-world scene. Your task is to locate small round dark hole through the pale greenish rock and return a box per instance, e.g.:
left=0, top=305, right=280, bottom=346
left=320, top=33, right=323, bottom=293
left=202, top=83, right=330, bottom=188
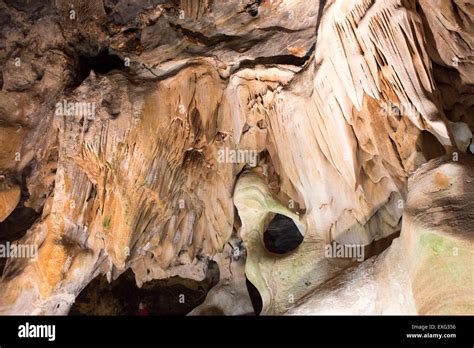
left=263, top=214, right=303, bottom=254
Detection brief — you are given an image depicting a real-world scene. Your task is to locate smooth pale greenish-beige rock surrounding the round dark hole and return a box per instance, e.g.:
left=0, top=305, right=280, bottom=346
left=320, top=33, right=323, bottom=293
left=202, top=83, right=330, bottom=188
left=234, top=170, right=352, bottom=315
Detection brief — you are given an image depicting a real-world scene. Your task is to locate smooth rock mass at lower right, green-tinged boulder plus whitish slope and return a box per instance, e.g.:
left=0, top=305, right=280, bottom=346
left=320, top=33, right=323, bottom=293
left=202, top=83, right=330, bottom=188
left=288, top=155, right=474, bottom=315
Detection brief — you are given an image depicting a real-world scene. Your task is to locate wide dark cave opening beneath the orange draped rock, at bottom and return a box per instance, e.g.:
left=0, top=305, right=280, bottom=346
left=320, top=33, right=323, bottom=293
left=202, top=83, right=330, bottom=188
left=69, top=261, right=219, bottom=315
